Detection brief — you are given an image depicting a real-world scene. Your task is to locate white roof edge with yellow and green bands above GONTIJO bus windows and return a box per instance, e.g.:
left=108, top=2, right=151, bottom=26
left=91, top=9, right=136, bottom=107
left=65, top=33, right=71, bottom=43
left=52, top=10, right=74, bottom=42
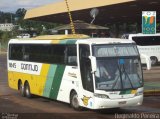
left=9, top=38, right=135, bottom=44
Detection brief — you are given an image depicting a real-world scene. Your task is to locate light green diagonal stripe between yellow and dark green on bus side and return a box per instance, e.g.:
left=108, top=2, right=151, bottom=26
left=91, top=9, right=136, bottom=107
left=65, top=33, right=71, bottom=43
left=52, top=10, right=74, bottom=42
left=43, top=65, right=57, bottom=97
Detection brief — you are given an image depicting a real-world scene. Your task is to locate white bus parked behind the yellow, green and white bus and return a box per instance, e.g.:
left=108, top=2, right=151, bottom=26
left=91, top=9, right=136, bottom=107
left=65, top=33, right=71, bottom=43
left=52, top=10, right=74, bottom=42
left=122, top=33, right=160, bottom=66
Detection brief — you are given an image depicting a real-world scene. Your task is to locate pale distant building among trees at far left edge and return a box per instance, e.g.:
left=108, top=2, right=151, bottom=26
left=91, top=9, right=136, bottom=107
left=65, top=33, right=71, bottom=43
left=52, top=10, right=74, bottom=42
left=0, top=23, right=14, bottom=31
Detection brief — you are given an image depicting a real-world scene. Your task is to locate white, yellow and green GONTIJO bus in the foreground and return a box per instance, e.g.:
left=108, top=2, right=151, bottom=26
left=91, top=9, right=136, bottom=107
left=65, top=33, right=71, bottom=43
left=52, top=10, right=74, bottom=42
left=7, top=35, right=143, bottom=110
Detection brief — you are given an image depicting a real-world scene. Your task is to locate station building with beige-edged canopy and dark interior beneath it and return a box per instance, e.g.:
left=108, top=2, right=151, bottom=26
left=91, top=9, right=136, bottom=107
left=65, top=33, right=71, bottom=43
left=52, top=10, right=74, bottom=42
left=24, top=0, right=160, bottom=37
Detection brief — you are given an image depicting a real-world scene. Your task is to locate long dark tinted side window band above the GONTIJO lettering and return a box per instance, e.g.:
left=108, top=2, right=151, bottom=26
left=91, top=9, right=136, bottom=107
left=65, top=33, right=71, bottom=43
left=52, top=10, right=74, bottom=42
left=9, top=44, right=77, bottom=65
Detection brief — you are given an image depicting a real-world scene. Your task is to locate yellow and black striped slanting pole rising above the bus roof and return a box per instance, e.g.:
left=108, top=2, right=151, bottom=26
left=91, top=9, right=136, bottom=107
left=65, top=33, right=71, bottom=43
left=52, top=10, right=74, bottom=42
left=65, top=0, right=76, bottom=35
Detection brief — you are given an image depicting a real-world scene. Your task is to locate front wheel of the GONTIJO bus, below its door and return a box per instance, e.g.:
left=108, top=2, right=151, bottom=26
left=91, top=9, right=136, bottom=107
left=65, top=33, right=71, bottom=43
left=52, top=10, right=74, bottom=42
left=70, top=91, right=80, bottom=110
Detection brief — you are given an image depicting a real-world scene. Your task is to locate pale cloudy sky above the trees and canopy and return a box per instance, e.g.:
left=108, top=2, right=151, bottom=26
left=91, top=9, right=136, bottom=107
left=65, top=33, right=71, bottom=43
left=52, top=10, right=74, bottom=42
left=0, top=0, right=62, bottom=13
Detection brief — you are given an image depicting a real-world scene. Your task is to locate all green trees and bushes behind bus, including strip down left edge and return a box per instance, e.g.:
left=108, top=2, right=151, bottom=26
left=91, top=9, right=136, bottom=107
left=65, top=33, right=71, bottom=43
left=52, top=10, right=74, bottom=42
left=0, top=8, right=59, bottom=50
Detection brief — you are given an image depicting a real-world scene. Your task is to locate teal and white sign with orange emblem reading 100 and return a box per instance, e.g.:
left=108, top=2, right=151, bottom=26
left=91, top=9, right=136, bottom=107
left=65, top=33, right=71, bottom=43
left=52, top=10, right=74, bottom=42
left=142, top=11, right=156, bottom=34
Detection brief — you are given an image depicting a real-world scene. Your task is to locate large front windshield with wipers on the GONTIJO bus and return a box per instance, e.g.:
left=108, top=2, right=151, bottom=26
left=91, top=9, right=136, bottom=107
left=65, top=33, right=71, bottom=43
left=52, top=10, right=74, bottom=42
left=94, top=46, right=143, bottom=90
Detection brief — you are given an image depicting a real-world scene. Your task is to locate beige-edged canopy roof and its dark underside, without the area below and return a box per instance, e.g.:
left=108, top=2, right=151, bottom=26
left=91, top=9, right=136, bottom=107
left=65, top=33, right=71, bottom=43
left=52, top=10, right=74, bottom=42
left=25, top=0, right=160, bottom=24
